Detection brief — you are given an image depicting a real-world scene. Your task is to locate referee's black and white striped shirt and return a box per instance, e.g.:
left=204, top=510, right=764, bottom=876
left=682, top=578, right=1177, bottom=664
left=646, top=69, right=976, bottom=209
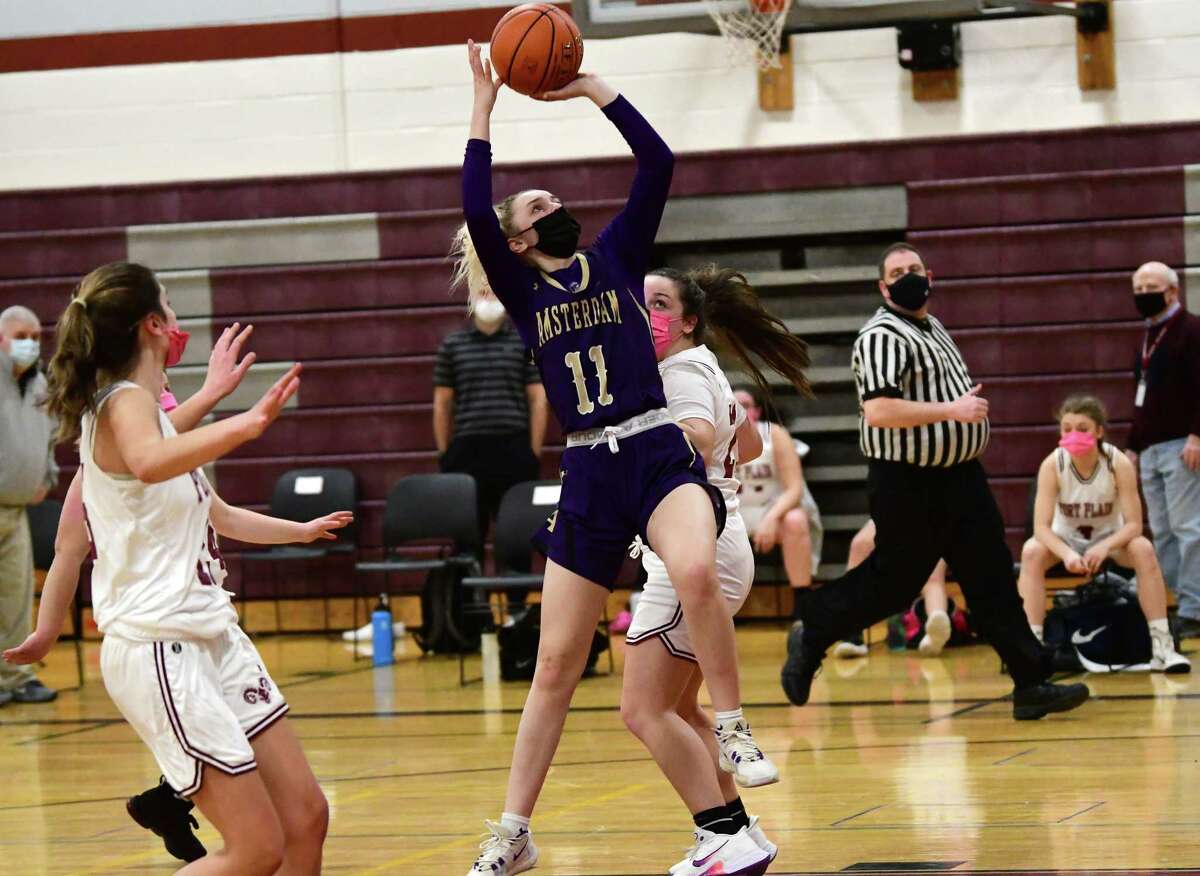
left=851, top=307, right=989, bottom=467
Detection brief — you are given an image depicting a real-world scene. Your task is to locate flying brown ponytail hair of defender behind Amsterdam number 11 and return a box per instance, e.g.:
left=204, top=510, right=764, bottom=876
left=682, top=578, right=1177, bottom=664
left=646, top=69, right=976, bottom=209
left=650, top=264, right=812, bottom=398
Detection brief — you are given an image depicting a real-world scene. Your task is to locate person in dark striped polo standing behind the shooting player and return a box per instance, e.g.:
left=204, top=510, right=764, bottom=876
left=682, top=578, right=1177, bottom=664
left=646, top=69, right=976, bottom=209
left=433, top=278, right=548, bottom=604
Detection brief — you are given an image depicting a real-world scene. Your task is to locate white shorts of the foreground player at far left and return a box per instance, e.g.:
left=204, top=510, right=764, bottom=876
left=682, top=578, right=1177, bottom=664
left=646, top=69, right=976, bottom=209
left=100, top=626, right=288, bottom=797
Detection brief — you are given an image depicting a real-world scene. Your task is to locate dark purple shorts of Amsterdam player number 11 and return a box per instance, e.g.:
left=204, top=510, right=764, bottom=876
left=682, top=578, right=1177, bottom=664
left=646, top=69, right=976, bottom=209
left=533, top=424, right=725, bottom=590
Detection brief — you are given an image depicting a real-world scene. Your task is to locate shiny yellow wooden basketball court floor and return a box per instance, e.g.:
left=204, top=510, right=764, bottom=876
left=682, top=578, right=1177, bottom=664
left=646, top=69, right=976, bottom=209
left=0, top=625, right=1200, bottom=876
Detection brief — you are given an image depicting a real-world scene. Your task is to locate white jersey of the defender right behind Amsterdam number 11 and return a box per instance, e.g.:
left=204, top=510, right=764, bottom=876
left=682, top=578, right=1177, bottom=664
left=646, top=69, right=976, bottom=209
left=659, top=344, right=746, bottom=515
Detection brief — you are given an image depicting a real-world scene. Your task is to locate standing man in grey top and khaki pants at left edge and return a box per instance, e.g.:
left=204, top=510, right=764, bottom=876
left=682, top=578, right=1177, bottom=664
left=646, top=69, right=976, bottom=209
left=0, top=306, right=59, bottom=706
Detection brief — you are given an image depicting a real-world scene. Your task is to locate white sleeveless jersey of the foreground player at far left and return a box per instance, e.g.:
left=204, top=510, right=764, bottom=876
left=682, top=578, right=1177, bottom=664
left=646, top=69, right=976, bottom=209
left=79, top=382, right=238, bottom=641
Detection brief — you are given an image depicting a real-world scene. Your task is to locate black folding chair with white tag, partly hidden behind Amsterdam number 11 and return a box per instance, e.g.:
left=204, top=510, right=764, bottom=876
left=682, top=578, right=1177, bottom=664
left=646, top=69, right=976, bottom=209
left=458, top=480, right=616, bottom=686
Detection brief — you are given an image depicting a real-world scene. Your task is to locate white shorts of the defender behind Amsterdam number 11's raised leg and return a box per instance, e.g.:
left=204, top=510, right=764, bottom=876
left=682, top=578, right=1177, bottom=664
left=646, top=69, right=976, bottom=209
left=625, top=514, right=754, bottom=661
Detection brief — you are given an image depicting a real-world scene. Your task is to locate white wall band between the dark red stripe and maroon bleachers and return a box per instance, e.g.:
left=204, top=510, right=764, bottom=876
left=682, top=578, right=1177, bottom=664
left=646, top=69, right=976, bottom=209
left=0, top=0, right=1200, bottom=188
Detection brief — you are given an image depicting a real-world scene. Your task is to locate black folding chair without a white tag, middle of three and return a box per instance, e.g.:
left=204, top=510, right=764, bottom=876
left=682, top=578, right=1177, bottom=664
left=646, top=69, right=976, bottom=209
left=354, top=473, right=482, bottom=660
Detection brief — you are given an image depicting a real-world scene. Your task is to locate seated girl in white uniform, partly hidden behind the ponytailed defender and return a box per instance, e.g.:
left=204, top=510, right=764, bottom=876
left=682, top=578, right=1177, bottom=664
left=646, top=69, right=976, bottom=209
left=733, top=386, right=824, bottom=612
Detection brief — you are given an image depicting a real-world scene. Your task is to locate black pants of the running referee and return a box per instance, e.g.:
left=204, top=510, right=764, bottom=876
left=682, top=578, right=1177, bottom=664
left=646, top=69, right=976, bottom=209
left=799, top=460, right=1051, bottom=688
